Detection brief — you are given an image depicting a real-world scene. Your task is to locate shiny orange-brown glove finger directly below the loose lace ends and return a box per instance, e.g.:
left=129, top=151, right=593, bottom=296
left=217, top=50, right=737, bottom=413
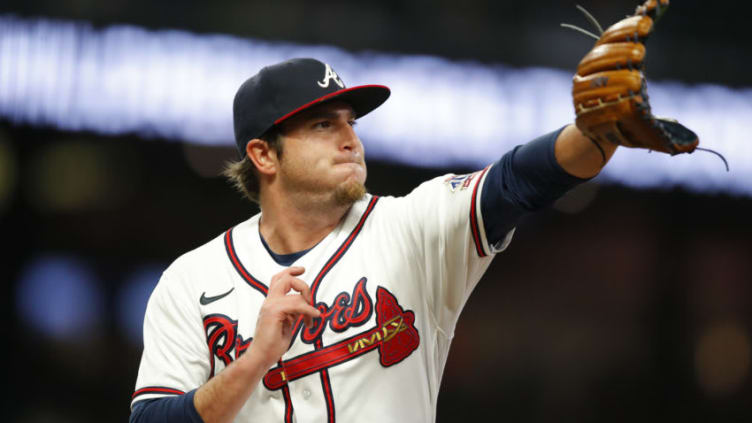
left=577, top=43, right=645, bottom=76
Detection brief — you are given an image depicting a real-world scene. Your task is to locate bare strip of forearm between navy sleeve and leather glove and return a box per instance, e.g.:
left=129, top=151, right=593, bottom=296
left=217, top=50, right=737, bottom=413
left=554, top=125, right=617, bottom=179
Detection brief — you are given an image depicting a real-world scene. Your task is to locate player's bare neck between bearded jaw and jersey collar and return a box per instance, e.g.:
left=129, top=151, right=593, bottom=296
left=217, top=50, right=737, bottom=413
left=259, top=192, right=351, bottom=254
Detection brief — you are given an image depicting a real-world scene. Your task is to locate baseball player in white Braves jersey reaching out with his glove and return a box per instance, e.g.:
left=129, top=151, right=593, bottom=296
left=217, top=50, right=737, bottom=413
left=131, top=1, right=697, bottom=423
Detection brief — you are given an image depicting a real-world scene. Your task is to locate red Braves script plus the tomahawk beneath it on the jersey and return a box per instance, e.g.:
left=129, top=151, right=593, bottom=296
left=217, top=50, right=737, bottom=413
left=204, top=278, right=420, bottom=390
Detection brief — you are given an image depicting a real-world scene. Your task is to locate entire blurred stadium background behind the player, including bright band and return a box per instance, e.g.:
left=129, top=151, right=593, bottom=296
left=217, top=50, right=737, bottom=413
left=0, top=0, right=752, bottom=423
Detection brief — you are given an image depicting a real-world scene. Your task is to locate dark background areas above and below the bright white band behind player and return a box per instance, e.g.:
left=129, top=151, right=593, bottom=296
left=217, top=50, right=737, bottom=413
left=0, top=0, right=752, bottom=422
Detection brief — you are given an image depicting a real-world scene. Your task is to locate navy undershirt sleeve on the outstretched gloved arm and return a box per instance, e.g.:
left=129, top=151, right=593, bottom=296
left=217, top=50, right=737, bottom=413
left=480, top=127, right=588, bottom=244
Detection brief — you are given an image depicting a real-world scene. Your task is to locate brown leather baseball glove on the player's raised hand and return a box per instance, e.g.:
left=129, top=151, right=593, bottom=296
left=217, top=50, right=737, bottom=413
left=565, top=0, right=699, bottom=158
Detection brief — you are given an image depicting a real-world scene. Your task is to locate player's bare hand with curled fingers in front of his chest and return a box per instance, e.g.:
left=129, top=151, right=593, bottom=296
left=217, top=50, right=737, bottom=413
left=250, top=266, right=321, bottom=366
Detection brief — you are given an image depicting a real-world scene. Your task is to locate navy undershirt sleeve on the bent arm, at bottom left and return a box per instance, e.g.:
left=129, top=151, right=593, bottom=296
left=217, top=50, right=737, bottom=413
left=128, top=389, right=204, bottom=423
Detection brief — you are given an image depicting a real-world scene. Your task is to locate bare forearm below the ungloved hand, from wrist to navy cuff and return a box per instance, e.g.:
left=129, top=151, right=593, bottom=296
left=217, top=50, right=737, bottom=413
left=193, top=344, right=270, bottom=423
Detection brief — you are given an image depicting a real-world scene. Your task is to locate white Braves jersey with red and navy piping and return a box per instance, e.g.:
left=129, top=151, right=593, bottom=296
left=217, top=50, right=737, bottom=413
left=133, top=169, right=513, bottom=422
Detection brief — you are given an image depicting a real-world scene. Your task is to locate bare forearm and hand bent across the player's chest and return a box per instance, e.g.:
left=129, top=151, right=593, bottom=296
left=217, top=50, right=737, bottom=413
left=193, top=266, right=320, bottom=423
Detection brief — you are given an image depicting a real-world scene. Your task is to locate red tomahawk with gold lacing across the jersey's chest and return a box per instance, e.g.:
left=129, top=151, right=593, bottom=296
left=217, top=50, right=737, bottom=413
left=264, top=287, right=420, bottom=390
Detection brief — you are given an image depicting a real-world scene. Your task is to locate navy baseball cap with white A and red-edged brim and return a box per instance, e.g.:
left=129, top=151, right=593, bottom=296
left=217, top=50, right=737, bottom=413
left=232, top=59, right=390, bottom=157
